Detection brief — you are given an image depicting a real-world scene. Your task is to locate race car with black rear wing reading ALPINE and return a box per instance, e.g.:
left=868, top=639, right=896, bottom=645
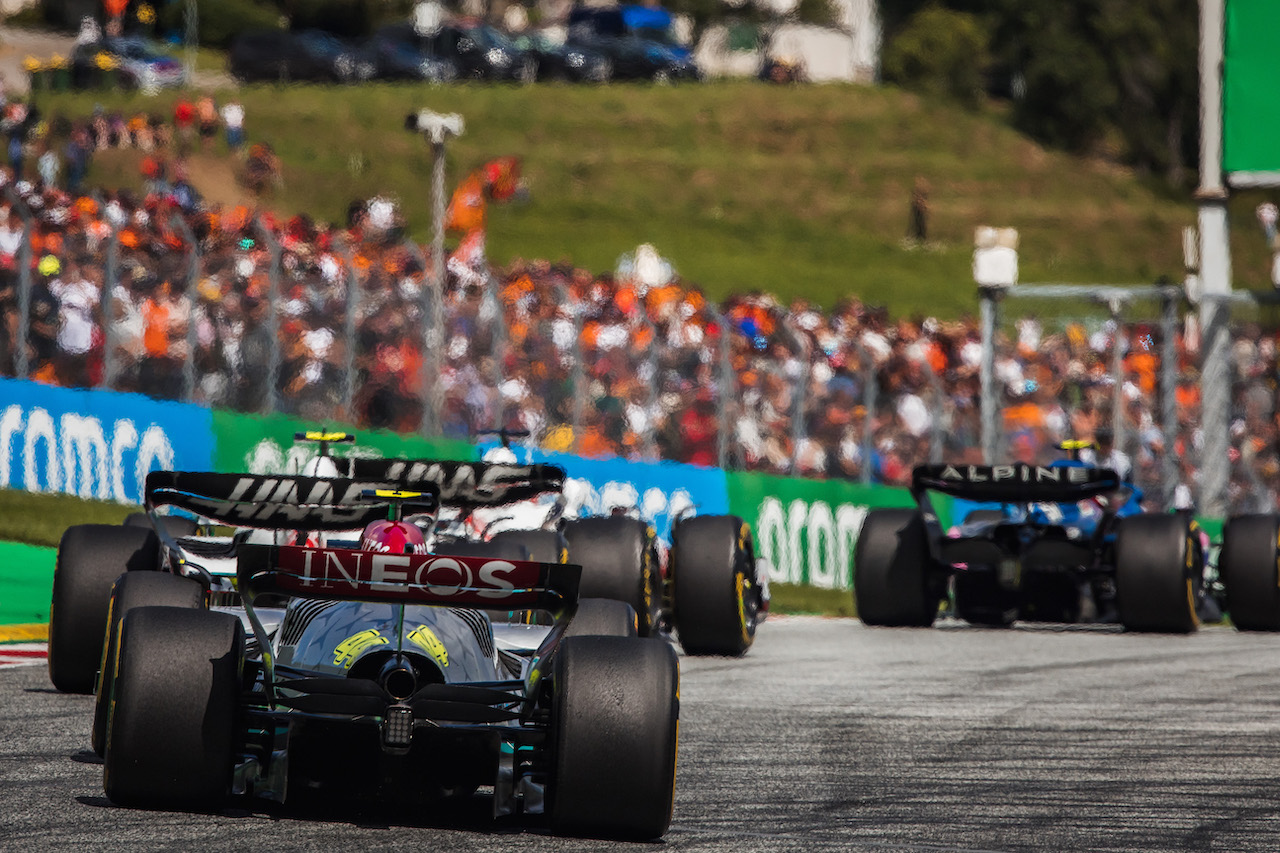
left=854, top=461, right=1207, bottom=633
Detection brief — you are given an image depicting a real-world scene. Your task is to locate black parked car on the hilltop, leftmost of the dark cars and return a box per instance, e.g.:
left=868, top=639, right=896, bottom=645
left=227, top=29, right=378, bottom=83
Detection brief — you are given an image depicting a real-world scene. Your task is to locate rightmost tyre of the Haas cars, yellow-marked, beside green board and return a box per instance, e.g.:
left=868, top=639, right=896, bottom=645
left=671, top=515, right=763, bottom=657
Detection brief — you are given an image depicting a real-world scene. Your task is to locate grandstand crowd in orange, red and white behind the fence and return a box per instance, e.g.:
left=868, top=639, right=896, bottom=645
left=0, top=99, right=1280, bottom=511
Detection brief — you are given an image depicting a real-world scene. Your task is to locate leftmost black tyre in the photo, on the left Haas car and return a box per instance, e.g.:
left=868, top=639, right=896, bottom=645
left=49, top=524, right=160, bottom=693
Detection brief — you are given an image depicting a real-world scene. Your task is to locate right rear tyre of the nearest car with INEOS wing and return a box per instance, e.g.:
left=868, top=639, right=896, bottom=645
left=548, top=637, right=680, bottom=839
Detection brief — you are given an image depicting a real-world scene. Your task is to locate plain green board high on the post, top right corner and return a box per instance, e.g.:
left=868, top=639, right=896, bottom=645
left=1222, top=0, right=1280, bottom=179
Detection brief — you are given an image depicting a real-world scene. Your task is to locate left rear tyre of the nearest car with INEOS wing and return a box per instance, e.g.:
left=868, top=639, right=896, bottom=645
left=102, top=607, right=244, bottom=811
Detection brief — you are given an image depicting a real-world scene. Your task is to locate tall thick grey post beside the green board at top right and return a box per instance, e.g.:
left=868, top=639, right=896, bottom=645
left=1196, top=0, right=1231, bottom=517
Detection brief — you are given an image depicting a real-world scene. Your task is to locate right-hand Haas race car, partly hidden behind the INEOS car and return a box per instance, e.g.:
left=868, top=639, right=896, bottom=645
left=351, top=459, right=769, bottom=657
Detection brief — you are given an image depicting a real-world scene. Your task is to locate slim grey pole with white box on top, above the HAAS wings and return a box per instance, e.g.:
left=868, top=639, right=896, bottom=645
left=404, top=110, right=463, bottom=435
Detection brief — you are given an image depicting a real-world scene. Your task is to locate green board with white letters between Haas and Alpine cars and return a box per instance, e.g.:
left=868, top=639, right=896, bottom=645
left=726, top=471, right=915, bottom=589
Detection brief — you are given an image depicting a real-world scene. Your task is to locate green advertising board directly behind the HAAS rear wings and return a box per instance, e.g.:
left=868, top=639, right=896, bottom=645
left=212, top=411, right=476, bottom=474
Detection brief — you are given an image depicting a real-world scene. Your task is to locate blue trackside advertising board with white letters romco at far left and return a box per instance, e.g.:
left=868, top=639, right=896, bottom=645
left=0, top=379, right=214, bottom=503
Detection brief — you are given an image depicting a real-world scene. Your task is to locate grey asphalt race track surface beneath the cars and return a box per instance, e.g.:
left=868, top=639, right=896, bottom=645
left=0, top=617, right=1280, bottom=853
